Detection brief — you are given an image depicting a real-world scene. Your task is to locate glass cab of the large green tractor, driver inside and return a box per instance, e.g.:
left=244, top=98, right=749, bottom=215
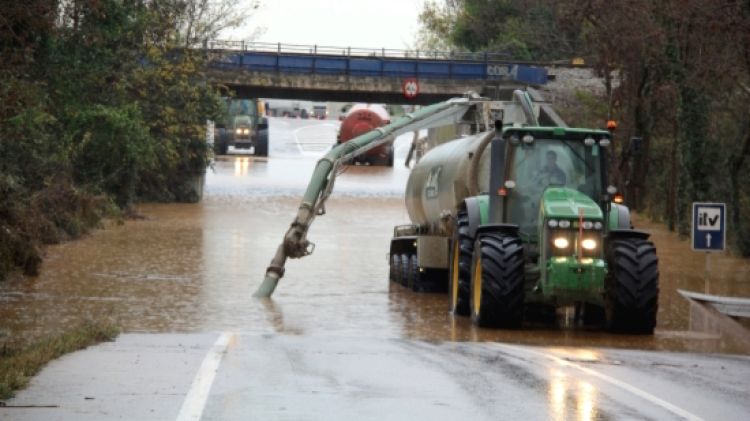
left=500, top=128, right=610, bottom=238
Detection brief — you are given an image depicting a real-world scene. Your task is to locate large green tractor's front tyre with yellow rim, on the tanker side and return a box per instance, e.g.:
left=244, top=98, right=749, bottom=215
left=469, top=233, right=524, bottom=328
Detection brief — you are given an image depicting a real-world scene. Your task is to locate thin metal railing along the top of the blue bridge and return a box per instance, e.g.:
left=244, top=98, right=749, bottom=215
left=203, top=40, right=511, bottom=62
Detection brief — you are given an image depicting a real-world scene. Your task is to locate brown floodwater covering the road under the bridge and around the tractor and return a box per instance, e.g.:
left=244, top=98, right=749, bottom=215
left=0, top=121, right=750, bottom=353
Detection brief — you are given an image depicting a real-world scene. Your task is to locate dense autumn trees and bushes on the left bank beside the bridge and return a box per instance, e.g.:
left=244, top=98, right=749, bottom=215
left=0, top=0, right=257, bottom=279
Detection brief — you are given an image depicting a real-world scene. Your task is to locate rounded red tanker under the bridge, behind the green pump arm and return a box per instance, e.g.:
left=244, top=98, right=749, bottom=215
left=336, top=104, right=393, bottom=167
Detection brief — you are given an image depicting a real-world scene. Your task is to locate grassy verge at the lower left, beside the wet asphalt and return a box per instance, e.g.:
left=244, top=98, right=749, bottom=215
left=0, top=322, right=120, bottom=399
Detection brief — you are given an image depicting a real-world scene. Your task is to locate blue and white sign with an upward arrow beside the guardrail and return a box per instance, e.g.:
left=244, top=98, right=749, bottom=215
left=692, top=202, right=727, bottom=251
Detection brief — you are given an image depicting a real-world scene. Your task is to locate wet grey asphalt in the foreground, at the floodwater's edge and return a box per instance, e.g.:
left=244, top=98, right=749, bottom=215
left=5, top=333, right=750, bottom=420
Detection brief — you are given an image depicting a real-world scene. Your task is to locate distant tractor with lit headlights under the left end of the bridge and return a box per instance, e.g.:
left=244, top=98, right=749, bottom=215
left=214, top=99, right=268, bottom=156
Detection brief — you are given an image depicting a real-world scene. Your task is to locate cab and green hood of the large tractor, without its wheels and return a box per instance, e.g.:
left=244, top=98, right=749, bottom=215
left=490, top=127, right=624, bottom=305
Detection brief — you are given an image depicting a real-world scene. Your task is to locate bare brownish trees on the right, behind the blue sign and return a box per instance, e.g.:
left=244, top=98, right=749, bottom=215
left=422, top=0, right=750, bottom=255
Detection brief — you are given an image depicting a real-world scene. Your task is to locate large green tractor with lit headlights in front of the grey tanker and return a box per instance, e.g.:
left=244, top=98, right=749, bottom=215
left=446, top=126, right=659, bottom=334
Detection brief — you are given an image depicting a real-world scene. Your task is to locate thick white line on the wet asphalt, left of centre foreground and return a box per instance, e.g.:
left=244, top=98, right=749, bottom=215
left=177, top=332, right=234, bottom=421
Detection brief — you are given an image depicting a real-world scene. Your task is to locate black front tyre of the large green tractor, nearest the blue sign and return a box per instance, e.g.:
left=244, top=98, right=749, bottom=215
left=604, top=238, right=659, bottom=335
